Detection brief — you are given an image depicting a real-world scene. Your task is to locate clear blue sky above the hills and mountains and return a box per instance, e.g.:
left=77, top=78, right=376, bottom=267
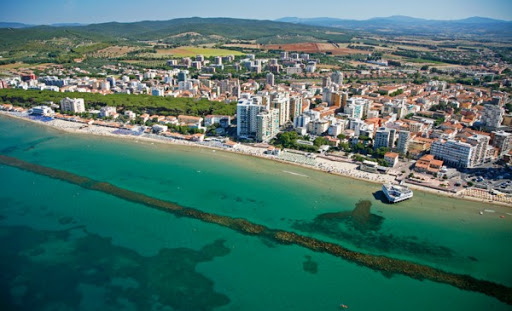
left=0, top=0, right=512, bottom=24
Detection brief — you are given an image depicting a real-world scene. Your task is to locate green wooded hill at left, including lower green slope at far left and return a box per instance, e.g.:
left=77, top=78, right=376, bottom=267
left=0, top=17, right=352, bottom=65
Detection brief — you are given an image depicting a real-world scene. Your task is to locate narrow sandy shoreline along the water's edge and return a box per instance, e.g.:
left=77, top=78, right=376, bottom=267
left=0, top=111, right=512, bottom=207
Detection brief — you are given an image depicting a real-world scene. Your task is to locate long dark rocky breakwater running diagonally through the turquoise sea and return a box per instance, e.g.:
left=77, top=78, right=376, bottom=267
left=0, top=155, right=512, bottom=305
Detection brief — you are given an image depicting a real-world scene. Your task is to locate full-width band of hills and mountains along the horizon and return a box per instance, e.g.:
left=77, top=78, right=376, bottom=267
left=0, top=16, right=512, bottom=50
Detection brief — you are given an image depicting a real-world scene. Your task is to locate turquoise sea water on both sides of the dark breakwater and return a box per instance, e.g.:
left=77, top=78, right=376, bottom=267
left=0, top=116, right=512, bottom=310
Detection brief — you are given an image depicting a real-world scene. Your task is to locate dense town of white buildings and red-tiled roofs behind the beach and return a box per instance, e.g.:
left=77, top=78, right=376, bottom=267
left=1, top=47, right=512, bottom=172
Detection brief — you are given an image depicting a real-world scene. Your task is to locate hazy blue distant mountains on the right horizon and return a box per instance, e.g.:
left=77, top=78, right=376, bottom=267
left=277, top=15, right=512, bottom=36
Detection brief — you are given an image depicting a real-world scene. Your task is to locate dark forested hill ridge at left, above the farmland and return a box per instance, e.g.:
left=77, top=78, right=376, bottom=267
left=0, top=17, right=352, bottom=49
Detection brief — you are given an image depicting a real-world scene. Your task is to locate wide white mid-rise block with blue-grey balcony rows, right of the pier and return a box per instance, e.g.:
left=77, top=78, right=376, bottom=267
left=430, top=140, right=474, bottom=168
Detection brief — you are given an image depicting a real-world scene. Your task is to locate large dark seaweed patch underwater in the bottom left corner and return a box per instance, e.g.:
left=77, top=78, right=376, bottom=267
left=0, top=227, right=230, bottom=310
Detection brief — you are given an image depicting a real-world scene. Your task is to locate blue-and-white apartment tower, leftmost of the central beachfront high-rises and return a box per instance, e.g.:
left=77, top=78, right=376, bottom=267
left=236, top=99, right=265, bottom=137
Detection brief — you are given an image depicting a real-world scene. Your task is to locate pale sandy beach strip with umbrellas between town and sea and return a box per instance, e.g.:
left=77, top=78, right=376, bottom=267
left=0, top=111, right=512, bottom=207
